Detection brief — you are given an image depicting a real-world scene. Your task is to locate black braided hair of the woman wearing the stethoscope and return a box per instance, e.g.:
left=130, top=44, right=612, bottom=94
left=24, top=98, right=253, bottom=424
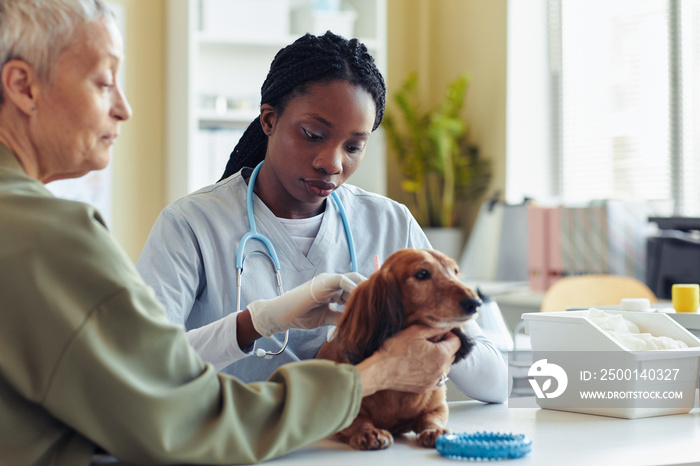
left=219, top=31, right=386, bottom=181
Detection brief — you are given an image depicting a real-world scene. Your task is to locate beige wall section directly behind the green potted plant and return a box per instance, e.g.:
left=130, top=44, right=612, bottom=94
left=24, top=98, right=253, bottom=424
left=387, top=0, right=507, bottom=235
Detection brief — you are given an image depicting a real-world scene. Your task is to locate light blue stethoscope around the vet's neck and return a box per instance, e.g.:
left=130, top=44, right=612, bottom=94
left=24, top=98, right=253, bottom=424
left=236, top=162, right=357, bottom=359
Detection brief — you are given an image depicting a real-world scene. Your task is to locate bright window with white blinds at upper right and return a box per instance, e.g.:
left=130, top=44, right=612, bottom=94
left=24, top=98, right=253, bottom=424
left=549, top=0, right=700, bottom=216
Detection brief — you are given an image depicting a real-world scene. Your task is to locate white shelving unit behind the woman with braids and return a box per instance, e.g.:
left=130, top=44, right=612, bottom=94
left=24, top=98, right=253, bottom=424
left=166, top=0, right=387, bottom=202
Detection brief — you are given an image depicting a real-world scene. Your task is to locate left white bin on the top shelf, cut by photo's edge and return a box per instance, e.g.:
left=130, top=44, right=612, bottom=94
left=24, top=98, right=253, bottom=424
left=201, top=0, right=290, bottom=40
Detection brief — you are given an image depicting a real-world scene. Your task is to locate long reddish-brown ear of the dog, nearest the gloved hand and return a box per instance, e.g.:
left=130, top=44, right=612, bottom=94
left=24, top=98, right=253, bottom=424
left=337, top=269, right=404, bottom=364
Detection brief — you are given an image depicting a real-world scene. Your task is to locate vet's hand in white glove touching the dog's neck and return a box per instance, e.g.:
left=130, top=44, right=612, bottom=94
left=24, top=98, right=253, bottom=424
left=248, top=272, right=365, bottom=337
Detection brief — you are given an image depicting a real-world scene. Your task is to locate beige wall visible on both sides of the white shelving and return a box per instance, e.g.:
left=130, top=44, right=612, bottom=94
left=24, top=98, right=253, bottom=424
left=106, top=0, right=507, bottom=261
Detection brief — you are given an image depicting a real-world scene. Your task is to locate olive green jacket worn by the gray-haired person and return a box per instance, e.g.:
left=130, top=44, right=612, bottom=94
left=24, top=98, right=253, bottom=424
left=0, top=145, right=361, bottom=466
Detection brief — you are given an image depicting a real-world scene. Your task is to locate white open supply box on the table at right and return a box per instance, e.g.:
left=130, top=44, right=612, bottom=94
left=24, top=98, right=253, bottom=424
left=522, top=310, right=700, bottom=419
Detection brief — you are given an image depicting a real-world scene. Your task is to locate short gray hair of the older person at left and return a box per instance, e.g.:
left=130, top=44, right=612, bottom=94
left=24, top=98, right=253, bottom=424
left=0, top=0, right=114, bottom=104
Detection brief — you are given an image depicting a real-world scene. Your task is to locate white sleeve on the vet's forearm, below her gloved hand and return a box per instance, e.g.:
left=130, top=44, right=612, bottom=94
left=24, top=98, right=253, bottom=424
left=187, top=312, right=253, bottom=371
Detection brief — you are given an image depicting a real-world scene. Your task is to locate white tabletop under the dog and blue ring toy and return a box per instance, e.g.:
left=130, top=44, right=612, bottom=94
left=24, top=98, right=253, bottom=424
left=95, top=401, right=700, bottom=466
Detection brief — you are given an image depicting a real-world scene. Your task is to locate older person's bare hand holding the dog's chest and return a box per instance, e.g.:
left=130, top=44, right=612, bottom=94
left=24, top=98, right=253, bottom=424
left=356, top=325, right=461, bottom=396
